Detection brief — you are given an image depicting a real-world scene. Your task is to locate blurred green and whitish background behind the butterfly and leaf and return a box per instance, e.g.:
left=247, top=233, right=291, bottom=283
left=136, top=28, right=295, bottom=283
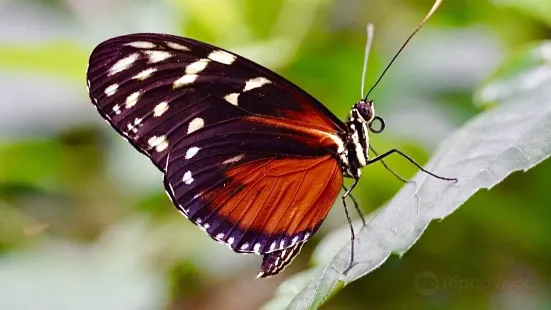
left=0, top=0, right=551, bottom=310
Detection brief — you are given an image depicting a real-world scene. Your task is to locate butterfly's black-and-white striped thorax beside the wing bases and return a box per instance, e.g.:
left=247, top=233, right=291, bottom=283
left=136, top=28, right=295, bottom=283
left=340, top=108, right=369, bottom=178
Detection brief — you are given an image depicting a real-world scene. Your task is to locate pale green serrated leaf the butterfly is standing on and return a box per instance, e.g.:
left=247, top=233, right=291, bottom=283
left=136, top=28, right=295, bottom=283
left=266, top=42, right=551, bottom=309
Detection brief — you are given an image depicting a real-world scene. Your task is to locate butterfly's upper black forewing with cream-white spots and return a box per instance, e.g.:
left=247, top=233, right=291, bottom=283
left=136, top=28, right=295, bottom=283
left=87, top=33, right=346, bottom=170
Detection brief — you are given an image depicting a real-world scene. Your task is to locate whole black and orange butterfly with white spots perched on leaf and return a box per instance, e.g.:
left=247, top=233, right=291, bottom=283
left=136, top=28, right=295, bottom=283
left=87, top=1, right=452, bottom=277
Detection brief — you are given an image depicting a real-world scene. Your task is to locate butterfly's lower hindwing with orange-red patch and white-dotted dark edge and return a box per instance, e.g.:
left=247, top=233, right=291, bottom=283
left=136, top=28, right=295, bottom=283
left=165, top=154, right=342, bottom=254
